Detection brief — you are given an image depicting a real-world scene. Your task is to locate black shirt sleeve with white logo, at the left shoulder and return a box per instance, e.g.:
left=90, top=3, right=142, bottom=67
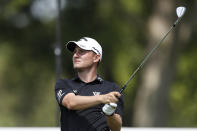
left=55, top=79, right=73, bottom=105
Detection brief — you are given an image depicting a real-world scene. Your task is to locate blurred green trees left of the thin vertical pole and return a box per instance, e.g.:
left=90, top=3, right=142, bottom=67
left=0, top=0, right=56, bottom=126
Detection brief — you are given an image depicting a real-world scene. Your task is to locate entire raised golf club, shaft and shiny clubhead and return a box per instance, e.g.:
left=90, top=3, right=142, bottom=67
left=120, top=6, right=186, bottom=94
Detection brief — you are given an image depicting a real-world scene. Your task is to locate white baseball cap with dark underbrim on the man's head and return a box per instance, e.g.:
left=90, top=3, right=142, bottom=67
left=66, top=37, right=102, bottom=61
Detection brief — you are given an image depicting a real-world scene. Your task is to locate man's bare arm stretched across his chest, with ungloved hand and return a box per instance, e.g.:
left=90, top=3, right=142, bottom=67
left=62, top=92, right=120, bottom=110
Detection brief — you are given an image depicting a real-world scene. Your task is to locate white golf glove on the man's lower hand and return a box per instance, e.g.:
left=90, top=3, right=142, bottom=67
left=102, top=103, right=117, bottom=116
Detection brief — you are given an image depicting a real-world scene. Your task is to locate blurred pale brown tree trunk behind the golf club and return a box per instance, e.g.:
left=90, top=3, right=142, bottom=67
left=133, top=0, right=177, bottom=126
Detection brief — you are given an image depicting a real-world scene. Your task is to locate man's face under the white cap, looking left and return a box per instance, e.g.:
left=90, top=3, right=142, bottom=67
left=73, top=46, right=98, bottom=69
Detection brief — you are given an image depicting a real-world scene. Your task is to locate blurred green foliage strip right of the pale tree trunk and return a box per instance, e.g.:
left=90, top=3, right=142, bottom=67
left=169, top=1, right=197, bottom=127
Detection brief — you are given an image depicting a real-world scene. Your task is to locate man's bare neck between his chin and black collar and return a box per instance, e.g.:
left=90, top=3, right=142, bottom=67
left=78, top=67, right=97, bottom=83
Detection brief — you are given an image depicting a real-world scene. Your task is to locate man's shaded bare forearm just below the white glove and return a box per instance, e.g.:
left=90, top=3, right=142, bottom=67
left=106, top=114, right=122, bottom=131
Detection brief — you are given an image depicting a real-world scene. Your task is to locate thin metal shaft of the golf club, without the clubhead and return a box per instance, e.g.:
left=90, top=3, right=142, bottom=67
left=120, top=18, right=181, bottom=94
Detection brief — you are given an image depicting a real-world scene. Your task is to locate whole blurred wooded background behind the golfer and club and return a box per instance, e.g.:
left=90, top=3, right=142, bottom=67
left=0, top=0, right=197, bottom=127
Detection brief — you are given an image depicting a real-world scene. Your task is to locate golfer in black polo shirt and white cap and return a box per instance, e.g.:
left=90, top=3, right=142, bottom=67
left=55, top=37, right=123, bottom=131
